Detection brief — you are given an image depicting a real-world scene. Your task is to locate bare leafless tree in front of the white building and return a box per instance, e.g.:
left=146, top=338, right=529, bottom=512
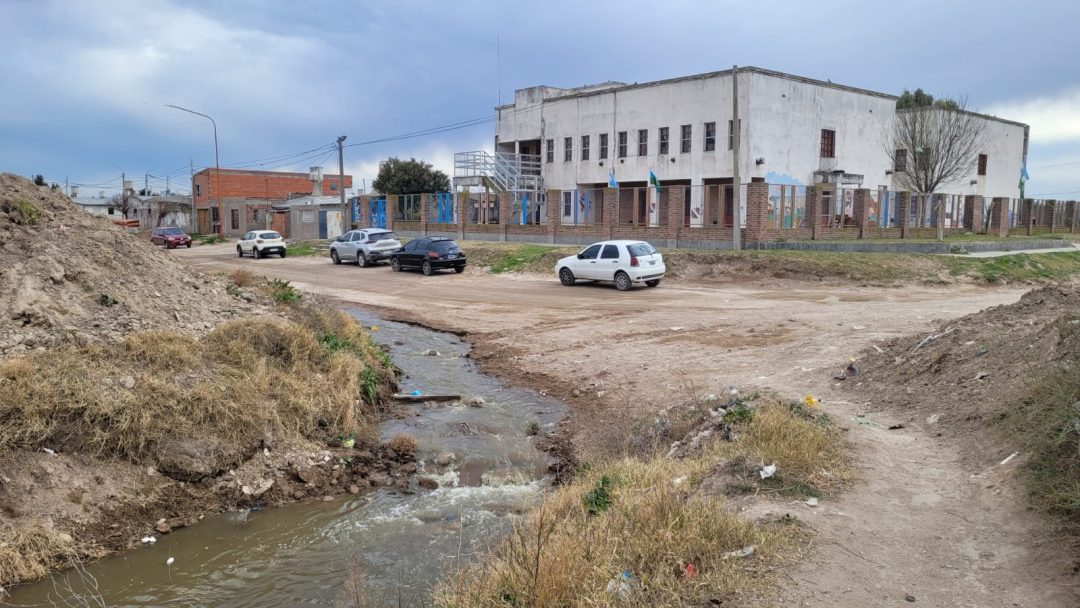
left=883, top=95, right=985, bottom=241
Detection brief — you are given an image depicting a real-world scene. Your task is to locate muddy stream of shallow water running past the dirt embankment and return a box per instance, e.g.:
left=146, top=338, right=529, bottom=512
left=9, top=311, right=564, bottom=608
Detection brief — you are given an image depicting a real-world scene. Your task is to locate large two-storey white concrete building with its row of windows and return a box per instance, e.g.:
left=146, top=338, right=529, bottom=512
left=477, top=67, right=1028, bottom=226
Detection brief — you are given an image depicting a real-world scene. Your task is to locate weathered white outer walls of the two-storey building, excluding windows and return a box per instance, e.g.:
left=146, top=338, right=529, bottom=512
left=496, top=68, right=1025, bottom=197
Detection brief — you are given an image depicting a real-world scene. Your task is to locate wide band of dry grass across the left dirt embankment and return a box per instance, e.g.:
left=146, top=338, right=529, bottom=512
left=0, top=310, right=389, bottom=461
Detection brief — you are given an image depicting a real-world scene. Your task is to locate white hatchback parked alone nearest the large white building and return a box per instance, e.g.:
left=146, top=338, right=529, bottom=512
left=555, top=241, right=666, bottom=292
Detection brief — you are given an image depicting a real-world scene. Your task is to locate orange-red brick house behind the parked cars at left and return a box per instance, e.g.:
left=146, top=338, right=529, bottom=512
left=191, top=167, right=352, bottom=237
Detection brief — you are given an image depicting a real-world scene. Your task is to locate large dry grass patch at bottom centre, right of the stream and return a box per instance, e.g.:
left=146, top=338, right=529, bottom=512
left=435, top=458, right=798, bottom=607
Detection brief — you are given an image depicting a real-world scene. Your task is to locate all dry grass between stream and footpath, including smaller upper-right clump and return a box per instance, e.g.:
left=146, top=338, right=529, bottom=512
left=435, top=396, right=851, bottom=608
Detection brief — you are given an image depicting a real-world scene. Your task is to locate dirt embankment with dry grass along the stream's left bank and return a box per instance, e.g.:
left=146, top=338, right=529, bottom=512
left=0, top=174, right=416, bottom=598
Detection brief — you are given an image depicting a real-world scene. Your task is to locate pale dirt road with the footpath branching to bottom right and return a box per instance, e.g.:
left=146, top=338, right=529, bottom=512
left=175, top=245, right=1075, bottom=607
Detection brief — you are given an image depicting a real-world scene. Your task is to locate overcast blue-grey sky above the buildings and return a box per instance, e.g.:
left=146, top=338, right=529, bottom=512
left=0, top=0, right=1080, bottom=198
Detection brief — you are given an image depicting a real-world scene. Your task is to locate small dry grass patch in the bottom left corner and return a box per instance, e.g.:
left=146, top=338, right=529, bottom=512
left=0, top=521, right=103, bottom=583
